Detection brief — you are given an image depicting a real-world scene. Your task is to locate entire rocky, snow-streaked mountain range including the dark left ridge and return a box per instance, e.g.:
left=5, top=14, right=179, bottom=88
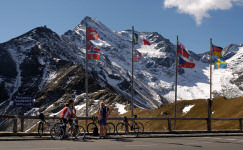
left=0, top=17, right=243, bottom=127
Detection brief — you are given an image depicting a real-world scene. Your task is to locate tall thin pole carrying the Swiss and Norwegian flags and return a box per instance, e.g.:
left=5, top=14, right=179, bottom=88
left=85, top=23, right=89, bottom=126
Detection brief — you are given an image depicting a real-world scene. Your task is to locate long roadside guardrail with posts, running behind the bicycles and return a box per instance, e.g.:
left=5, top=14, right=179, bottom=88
left=0, top=115, right=243, bottom=133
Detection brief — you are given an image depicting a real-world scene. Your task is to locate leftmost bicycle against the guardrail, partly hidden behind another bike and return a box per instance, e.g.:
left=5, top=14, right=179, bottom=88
left=38, top=113, right=56, bottom=137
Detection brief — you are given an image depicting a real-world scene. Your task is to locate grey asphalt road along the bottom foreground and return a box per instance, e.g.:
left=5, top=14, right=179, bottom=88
left=0, top=136, right=243, bottom=150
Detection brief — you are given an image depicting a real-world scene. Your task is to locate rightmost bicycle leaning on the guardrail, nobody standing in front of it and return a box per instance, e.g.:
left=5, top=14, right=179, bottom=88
left=116, top=115, right=144, bottom=135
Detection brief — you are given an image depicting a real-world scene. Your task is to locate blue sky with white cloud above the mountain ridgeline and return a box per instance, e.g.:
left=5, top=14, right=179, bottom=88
left=0, top=0, right=243, bottom=53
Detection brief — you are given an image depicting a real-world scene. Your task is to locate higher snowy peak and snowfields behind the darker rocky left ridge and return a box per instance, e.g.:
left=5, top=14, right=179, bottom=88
left=65, top=17, right=242, bottom=104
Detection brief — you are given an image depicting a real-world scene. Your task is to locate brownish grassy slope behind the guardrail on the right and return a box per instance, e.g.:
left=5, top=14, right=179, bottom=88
left=109, top=97, right=243, bottom=131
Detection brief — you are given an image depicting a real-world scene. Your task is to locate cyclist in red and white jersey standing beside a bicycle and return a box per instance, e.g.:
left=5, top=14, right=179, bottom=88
left=60, top=100, right=76, bottom=136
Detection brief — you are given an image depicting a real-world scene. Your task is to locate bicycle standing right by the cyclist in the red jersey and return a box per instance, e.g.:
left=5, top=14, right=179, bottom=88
left=50, top=118, right=85, bottom=140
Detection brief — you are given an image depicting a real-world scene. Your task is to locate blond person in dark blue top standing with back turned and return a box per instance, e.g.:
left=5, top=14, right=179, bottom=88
left=97, top=102, right=111, bottom=138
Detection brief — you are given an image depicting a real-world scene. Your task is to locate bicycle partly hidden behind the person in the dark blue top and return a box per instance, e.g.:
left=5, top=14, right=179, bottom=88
left=87, top=116, right=115, bottom=134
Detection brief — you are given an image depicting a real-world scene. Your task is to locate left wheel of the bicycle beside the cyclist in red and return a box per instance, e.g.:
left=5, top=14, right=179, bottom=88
left=50, top=123, right=64, bottom=140
